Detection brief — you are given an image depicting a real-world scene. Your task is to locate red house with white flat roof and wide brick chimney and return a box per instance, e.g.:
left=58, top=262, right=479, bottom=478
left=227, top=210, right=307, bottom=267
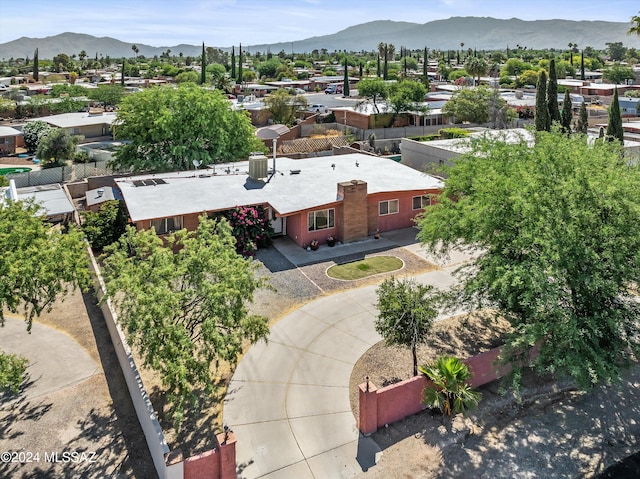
left=115, top=153, right=443, bottom=247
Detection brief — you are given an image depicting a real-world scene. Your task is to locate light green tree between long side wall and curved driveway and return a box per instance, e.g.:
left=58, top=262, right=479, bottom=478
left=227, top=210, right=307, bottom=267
left=103, top=216, right=269, bottom=429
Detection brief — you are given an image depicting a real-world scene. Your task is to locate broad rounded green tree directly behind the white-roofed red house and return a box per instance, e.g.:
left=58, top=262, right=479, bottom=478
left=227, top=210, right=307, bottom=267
left=113, top=83, right=261, bottom=171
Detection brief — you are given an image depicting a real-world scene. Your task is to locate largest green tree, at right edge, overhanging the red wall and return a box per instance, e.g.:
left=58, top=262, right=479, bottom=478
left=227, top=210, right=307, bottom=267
left=419, top=131, right=640, bottom=388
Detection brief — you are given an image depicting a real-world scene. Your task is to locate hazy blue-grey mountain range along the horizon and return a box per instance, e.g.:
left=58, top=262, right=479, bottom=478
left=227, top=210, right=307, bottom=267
left=0, top=17, right=640, bottom=59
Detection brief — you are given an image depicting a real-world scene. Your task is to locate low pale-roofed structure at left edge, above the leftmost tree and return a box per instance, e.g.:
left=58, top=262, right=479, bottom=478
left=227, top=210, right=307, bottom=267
left=3, top=180, right=75, bottom=224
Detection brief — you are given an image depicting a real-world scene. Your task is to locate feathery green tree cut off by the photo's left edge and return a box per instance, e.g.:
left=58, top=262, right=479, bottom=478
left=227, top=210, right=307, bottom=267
left=0, top=201, right=89, bottom=331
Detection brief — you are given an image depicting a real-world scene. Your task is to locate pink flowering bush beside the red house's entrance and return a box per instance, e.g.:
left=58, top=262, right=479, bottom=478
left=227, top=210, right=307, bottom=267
left=221, top=206, right=273, bottom=256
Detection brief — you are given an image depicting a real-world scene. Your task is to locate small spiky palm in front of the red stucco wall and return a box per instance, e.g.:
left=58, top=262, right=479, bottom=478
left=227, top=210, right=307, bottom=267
left=419, top=356, right=482, bottom=418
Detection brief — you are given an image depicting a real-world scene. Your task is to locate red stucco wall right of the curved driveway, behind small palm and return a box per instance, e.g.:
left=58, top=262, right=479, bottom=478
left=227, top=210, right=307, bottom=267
left=358, top=348, right=524, bottom=434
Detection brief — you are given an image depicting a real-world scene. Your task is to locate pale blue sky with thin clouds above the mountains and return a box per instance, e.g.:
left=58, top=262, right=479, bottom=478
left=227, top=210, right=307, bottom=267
left=0, top=0, right=640, bottom=47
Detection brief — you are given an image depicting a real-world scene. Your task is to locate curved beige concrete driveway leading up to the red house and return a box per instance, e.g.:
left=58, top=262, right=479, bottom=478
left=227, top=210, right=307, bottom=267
left=224, top=240, right=465, bottom=479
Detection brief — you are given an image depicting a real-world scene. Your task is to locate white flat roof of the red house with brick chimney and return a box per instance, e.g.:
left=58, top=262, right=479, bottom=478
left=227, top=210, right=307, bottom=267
left=115, top=153, right=444, bottom=222
